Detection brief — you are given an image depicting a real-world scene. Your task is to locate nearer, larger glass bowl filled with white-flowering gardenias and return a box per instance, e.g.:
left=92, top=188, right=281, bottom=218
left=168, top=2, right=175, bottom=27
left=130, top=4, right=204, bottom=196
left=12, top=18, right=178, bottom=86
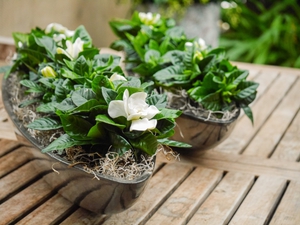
left=1, top=23, right=189, bottom=213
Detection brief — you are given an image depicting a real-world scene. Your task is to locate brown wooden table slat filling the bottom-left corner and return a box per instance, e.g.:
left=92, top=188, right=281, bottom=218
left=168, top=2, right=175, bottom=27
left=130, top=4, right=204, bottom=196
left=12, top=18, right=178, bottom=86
left=0, top=180, right=52, bottom=224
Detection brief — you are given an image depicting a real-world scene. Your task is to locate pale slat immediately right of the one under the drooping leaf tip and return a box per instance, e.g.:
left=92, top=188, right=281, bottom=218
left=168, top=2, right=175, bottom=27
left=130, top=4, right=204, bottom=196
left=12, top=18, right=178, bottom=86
left=243, top=76, right=300, bottom=157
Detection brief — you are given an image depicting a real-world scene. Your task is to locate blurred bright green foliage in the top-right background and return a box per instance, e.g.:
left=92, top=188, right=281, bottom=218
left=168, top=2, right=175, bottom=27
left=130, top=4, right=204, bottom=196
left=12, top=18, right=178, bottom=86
left=220, top=0, right=300, bottom=68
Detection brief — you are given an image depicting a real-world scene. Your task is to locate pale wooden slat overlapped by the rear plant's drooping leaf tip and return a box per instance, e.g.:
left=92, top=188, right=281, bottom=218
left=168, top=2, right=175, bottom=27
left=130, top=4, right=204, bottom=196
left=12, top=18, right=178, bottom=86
left=214, top=74, right=297, bottom=154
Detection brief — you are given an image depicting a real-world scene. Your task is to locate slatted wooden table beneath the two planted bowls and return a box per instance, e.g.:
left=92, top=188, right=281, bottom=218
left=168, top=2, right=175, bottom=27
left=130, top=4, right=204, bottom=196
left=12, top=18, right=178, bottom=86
left=0, top=59, right=300, bottom=225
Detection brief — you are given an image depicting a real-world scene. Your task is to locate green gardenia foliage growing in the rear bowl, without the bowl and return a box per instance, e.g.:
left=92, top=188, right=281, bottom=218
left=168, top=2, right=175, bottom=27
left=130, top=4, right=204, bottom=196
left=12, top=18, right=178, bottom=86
left=110, top=12, right=258, bottom=122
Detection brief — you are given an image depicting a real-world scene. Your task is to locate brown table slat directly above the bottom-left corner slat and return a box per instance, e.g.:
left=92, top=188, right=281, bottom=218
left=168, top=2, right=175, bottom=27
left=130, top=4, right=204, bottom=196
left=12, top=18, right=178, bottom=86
left=0, top=161, right=51, bottom=201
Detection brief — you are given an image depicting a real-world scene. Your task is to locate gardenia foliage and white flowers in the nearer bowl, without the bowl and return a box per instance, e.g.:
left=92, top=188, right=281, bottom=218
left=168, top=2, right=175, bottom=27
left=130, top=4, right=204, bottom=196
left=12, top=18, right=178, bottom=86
left=2, top=24, right=189, bottom=178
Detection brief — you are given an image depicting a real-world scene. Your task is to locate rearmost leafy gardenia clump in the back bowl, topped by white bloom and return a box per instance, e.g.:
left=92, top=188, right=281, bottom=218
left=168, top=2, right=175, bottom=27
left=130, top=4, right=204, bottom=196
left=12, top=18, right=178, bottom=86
left=110, top=11, right=188, bottom=78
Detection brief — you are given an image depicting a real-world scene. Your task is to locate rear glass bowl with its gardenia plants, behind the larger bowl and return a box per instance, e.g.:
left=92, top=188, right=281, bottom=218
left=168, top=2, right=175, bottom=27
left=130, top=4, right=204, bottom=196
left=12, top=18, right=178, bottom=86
left=110, top=12, right=258, bottom=152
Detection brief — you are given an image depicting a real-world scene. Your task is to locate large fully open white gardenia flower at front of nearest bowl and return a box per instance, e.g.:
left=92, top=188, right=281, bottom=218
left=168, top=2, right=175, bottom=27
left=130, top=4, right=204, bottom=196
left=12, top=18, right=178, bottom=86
left=108, top=89, right=160, bottom=131
